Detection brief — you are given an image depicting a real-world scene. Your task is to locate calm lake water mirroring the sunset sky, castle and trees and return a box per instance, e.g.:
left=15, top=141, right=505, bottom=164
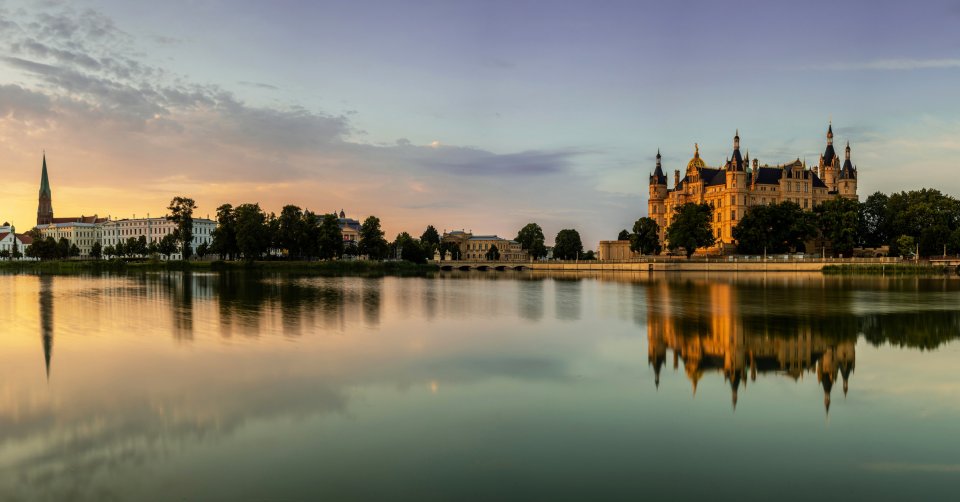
left=0, top=272, right=960, bottom=501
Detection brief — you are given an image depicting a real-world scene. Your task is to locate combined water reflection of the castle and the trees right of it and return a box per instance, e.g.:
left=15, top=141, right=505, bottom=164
left=642, top=277, right=960, bottom=412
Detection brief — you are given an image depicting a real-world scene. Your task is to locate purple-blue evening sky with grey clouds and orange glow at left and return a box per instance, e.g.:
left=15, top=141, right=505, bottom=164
left=0, top=0, right=960, bottom=249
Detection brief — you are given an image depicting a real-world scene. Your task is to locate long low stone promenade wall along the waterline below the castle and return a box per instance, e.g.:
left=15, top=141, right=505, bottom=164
left=436, top=256, right=904, bottom=272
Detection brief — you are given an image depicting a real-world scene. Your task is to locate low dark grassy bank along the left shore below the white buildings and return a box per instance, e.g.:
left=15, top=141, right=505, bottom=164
left=0, top=259, right=439, bottom=276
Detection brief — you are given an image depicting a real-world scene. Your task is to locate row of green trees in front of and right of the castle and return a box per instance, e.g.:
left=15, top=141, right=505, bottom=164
left=618, top=188, right=960, bottom=258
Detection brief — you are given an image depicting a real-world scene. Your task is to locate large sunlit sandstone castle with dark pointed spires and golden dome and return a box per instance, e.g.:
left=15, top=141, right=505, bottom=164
left=647, top=124, right=857, bottom=252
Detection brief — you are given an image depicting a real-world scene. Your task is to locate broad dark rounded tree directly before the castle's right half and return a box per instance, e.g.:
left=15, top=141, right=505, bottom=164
left=733, top=202, right=817, bottom=254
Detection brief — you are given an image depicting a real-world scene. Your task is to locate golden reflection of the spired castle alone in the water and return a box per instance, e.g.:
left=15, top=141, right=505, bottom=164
left=646, top=281, right=857, bottom=412
